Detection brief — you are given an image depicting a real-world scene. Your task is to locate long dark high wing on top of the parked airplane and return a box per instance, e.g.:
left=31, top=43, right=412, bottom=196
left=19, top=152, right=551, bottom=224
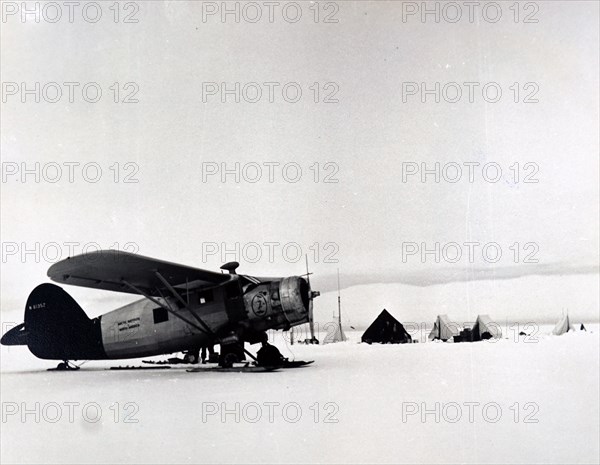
left=48, top=250, right=231, bottom=297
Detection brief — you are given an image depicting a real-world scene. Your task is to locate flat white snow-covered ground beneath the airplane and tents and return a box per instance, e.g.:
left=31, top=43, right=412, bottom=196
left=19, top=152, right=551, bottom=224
left=0, top=326, right=600, bottom=463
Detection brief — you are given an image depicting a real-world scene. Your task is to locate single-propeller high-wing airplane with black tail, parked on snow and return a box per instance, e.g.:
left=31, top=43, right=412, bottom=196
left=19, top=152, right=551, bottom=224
left=0, top=250, right=320, bottom=370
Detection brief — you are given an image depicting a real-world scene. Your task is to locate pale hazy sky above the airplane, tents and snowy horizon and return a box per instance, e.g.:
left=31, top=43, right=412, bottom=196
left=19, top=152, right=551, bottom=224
left=0, top=1, right=599, bottom=318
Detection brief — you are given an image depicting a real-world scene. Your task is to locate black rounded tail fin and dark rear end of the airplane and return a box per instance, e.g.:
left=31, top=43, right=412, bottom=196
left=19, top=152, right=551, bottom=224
left=25, top=284, right=106, bottom=360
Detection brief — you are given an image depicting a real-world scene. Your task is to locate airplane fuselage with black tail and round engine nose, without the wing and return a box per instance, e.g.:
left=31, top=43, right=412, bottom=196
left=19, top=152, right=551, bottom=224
left=2, top=274, right=311, bottom=360
